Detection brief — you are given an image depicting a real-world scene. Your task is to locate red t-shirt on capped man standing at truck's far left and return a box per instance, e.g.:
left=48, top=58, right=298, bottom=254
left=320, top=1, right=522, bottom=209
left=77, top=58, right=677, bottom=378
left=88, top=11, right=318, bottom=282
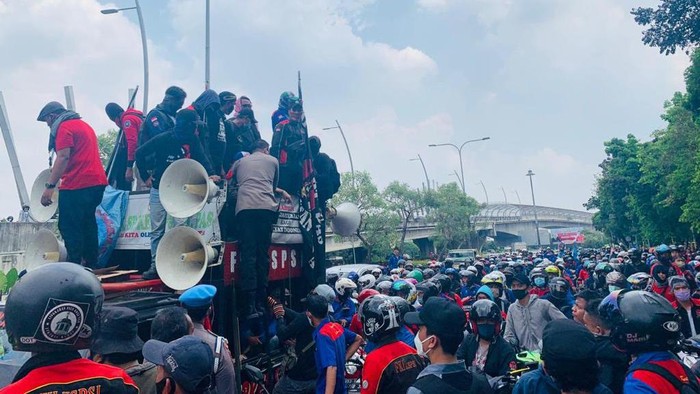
left=56, top=119, right=107, bottom=190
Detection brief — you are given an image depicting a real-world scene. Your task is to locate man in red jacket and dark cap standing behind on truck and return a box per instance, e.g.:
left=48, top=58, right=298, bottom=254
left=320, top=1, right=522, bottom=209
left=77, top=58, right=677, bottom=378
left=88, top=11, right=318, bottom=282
left=105, top=103, right=143, bottom=191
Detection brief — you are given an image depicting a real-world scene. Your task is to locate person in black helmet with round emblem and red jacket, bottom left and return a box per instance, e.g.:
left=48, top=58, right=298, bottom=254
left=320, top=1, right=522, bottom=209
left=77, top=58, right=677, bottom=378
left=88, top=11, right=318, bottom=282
left=0, top=263, right=139, bottom=394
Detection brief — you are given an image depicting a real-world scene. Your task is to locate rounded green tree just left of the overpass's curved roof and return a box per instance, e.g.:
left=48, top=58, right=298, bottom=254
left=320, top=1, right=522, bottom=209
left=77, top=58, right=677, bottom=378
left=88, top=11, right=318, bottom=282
left=426, top=182, right=479, bottom=251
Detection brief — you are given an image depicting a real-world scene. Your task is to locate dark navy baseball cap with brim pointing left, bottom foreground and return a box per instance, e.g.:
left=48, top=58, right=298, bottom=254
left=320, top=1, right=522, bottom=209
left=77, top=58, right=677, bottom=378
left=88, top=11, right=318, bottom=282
left=143, top=335, right=214, bottom=393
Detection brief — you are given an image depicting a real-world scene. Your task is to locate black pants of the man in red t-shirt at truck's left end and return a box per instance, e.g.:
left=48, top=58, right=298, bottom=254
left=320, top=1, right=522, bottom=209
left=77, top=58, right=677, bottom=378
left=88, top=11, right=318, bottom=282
left=58, top=186, right=105, bottom=267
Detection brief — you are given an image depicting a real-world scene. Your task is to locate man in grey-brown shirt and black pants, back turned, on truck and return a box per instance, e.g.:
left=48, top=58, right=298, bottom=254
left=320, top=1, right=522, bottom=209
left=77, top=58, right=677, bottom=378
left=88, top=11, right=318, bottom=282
left=233, top=140, right=291, bottom=319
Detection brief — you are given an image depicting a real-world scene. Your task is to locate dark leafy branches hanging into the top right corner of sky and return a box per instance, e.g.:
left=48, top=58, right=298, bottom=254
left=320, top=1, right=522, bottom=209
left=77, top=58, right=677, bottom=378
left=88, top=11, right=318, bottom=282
left=631, top=0, right=700, bottom=55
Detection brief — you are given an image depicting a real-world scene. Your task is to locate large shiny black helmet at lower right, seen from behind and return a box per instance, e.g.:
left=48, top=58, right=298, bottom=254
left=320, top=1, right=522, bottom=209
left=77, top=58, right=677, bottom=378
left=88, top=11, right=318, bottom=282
left=598, top=290, right=681, bottom=354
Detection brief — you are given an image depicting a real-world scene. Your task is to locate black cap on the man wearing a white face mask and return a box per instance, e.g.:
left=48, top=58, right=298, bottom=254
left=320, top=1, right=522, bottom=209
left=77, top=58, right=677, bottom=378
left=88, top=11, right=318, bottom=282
left=404, top=297, right=467, bottom=335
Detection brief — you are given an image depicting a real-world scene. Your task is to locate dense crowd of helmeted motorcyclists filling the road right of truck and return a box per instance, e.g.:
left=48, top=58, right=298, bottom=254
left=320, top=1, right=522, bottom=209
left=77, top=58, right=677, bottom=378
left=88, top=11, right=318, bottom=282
left=296, top=244, right=700, bottom=393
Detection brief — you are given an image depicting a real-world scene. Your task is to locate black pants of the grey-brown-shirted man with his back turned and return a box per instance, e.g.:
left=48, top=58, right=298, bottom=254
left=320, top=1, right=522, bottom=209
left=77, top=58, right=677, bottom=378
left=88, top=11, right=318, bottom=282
left=236, top=209, right=277, bottom=292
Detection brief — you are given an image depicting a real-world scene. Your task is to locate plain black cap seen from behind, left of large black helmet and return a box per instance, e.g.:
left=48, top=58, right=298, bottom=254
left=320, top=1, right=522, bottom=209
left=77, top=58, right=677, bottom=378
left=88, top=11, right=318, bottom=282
left=542, top=319, right=596, bottom=362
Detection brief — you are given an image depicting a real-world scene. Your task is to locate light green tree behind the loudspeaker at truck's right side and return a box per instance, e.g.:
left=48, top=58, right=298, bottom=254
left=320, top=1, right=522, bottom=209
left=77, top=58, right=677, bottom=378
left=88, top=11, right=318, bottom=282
left=332, top=171, right=401, bottom=262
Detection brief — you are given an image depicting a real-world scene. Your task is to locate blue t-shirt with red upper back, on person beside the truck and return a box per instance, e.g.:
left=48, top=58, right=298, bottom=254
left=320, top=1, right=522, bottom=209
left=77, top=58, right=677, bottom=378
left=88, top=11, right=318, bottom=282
left=313, top=318, right=357, bottom=394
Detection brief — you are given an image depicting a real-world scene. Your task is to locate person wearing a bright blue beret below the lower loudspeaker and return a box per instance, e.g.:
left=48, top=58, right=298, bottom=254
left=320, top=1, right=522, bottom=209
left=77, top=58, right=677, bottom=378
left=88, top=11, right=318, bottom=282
left=179, top=285, right=236, bottom=394
